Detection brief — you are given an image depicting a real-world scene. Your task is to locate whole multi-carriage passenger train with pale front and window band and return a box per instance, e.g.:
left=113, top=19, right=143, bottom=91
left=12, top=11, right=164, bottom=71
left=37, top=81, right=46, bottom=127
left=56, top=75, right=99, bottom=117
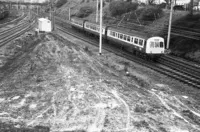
left=70, top=17, right=165, bottom=59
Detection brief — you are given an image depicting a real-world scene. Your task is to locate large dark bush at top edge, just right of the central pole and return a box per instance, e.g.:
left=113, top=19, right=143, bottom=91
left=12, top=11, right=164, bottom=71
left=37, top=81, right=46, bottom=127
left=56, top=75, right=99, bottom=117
left=109, top=1, right=138, bottom=16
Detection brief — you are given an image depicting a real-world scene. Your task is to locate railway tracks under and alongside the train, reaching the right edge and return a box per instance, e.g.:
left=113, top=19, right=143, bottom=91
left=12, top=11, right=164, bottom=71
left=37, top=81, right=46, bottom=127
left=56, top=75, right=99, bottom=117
left=54, top=18, right=200, bottom=88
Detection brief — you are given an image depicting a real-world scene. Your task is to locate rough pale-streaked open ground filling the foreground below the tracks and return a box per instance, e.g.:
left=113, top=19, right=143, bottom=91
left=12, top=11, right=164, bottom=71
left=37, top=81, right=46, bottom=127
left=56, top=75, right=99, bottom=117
left=0, top=32, right=200, bottom=132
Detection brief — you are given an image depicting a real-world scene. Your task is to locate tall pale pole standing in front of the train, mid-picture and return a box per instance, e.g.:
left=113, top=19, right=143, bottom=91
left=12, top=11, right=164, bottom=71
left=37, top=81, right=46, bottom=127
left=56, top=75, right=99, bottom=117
left=99, top=0, right=103, bottom=55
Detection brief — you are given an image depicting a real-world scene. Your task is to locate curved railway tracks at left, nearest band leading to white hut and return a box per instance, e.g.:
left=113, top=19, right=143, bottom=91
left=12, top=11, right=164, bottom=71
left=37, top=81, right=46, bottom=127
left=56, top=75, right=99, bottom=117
left=0, top=14, right=35, bottom=47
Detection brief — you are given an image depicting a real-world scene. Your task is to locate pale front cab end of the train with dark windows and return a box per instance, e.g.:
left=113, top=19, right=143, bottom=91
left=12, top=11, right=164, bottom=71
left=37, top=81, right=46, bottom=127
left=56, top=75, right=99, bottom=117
left=146, top=37, right=165, bottom=59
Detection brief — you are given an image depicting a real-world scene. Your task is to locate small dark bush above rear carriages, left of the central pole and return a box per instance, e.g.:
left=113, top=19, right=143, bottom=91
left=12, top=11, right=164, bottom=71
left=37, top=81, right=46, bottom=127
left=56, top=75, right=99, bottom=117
left=76, top=6, right=93, bottom=18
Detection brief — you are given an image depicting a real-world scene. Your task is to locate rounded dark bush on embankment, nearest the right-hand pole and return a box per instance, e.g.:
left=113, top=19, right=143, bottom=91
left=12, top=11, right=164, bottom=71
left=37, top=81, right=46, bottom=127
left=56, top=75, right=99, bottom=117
left=137, top=6, right=163, bottom=21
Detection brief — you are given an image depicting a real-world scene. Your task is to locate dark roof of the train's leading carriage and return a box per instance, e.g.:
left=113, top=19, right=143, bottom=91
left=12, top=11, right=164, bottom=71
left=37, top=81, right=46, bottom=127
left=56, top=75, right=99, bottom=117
left=108, top=26, right=151, bottom=39
